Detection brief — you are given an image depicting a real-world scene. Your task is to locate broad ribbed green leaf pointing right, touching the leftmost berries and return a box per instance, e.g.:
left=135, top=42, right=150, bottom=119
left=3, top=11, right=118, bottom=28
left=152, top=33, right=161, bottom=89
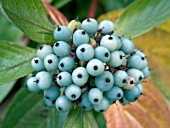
left=0, top=41, right=36, bottom=84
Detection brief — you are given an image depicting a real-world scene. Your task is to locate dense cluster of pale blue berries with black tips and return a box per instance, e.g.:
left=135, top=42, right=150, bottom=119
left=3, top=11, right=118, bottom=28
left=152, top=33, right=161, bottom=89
left=27, top=18, right=150, bottom=112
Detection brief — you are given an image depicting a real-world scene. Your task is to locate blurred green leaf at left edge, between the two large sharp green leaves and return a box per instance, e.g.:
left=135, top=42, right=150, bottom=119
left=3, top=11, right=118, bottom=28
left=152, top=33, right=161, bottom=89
left=0, top=14, right=23, bottom=42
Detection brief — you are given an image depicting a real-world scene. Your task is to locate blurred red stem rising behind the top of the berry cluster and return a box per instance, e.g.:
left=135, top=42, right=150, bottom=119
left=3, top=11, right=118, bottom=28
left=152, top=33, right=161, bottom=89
left=88, top=0, right=97, bottom=18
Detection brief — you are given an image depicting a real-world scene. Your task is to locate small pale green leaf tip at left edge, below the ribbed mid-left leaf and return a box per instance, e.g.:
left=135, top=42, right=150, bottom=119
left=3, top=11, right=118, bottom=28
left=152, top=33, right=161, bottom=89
left=0, top=81, right=16, bottom=104
